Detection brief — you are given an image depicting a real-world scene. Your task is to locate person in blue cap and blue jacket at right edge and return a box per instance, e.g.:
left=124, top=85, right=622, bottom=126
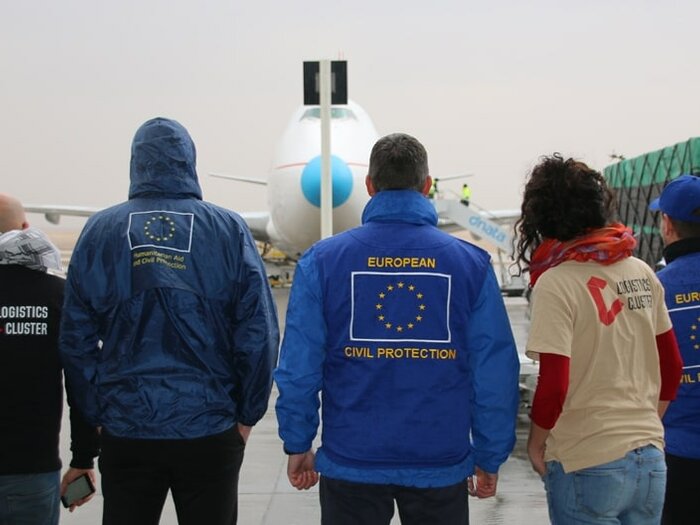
left=649, top=175, right=700, bottom=525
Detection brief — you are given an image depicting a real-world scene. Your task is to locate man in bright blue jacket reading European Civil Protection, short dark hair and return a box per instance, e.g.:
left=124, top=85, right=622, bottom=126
left=275, top=134, right=519, bottom=525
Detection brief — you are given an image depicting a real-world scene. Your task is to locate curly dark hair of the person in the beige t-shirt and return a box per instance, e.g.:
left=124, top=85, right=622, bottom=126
left=515, top=153, right=615, bottom=268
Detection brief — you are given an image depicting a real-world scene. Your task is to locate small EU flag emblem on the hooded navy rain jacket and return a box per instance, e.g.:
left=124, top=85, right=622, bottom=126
left=129, top=210, right=194, bottom=253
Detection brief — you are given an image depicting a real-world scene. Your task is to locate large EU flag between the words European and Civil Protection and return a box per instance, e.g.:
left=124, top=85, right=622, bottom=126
left=350, top=272, right=452, bottom=343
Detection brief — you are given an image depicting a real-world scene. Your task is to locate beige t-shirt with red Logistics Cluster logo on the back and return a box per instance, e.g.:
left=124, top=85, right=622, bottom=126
left=526, top=257, right=671, bottom=472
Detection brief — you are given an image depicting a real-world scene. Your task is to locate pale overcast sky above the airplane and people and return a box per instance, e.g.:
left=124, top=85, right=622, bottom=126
left=0, top=0, right=700, bottom=226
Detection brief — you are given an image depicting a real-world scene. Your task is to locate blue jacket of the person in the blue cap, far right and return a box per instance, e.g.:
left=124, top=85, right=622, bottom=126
left=658, top=243, right=700, bottom=459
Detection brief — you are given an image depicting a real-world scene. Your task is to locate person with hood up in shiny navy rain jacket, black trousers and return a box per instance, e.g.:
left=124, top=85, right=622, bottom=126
left=60, top=118, right=279, bottom=525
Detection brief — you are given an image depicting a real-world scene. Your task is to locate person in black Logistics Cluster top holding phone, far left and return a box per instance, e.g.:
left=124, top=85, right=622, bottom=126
left=0, top=194, right=99, bottom=525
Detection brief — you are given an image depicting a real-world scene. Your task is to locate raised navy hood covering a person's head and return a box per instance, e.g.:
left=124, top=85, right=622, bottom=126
left=129, top=118, right=202, bottom=199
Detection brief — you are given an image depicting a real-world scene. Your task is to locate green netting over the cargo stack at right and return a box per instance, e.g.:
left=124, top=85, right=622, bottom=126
left=603, top=137, right=700, bottom=267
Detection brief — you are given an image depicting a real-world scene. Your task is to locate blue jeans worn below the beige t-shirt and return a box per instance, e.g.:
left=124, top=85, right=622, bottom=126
left=544, top=445, right=666, bottom=525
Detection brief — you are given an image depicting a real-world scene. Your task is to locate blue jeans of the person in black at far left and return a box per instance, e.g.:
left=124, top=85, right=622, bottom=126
left=0, top=470, right=61, bottom=525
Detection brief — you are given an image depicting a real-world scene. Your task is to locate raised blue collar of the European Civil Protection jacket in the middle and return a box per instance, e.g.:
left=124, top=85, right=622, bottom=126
left=362, top=190, right=438, bottom=226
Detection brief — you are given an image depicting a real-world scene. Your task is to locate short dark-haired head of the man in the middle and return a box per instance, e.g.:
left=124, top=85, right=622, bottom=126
left=369, top=133, right=428, bottom=191
